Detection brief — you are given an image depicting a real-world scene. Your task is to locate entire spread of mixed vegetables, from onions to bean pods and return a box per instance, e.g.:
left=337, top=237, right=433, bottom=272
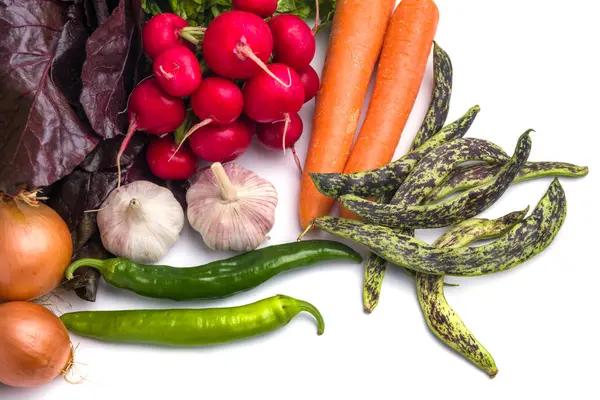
left=0, top=0, right=588, bottom=387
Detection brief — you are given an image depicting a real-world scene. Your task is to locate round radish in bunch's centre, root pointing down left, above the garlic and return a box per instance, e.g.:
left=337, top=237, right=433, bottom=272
left=175, top=76, right=244, bottom=155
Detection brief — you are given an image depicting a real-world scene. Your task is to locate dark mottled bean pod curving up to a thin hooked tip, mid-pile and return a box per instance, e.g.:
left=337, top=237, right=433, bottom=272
left=340, top=131, right=531, bottom=229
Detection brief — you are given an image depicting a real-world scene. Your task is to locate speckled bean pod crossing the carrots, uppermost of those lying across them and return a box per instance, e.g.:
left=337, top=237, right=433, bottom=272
left=309, top=106, right=479, bottom=198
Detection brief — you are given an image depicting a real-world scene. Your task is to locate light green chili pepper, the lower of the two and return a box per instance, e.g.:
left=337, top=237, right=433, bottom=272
left=60, top=295, right=325, bottom=346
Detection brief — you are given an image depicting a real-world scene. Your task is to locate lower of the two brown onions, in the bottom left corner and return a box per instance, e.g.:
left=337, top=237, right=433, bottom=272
left=0, top=301, right=73, bottom=387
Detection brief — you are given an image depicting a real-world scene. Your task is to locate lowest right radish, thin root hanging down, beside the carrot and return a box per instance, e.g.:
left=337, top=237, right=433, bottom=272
left=256, top=113, right=304, bottom=173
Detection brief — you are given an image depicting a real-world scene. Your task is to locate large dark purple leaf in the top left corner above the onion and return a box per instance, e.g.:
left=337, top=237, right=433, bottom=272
left=0, top=0, right=97, bottom=192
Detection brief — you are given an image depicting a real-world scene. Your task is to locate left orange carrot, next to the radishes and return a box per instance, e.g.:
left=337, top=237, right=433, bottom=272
left=298, top=0, right=395, bottom=228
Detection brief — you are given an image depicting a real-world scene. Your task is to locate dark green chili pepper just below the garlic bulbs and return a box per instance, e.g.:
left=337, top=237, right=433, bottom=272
left=66, top=240, right=362, bottom=301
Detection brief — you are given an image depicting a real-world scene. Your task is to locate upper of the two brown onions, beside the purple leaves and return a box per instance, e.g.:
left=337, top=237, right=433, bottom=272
left=0, top=192, right=73, bottom=300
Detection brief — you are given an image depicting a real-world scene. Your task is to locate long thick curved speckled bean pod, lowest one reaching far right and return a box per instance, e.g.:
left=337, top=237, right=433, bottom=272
left=306, top=179, right=567, bottom=276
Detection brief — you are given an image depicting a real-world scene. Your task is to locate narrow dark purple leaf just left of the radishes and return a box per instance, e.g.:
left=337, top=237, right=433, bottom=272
left=80, top=0, right=140, bottom=139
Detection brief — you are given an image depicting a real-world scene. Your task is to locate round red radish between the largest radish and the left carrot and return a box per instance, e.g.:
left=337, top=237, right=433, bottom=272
left=269, top=14, right=316, bottom=71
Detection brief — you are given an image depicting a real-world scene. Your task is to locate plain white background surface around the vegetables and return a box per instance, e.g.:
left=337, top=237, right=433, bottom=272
left=0, top=0, right=600, bottom=400
